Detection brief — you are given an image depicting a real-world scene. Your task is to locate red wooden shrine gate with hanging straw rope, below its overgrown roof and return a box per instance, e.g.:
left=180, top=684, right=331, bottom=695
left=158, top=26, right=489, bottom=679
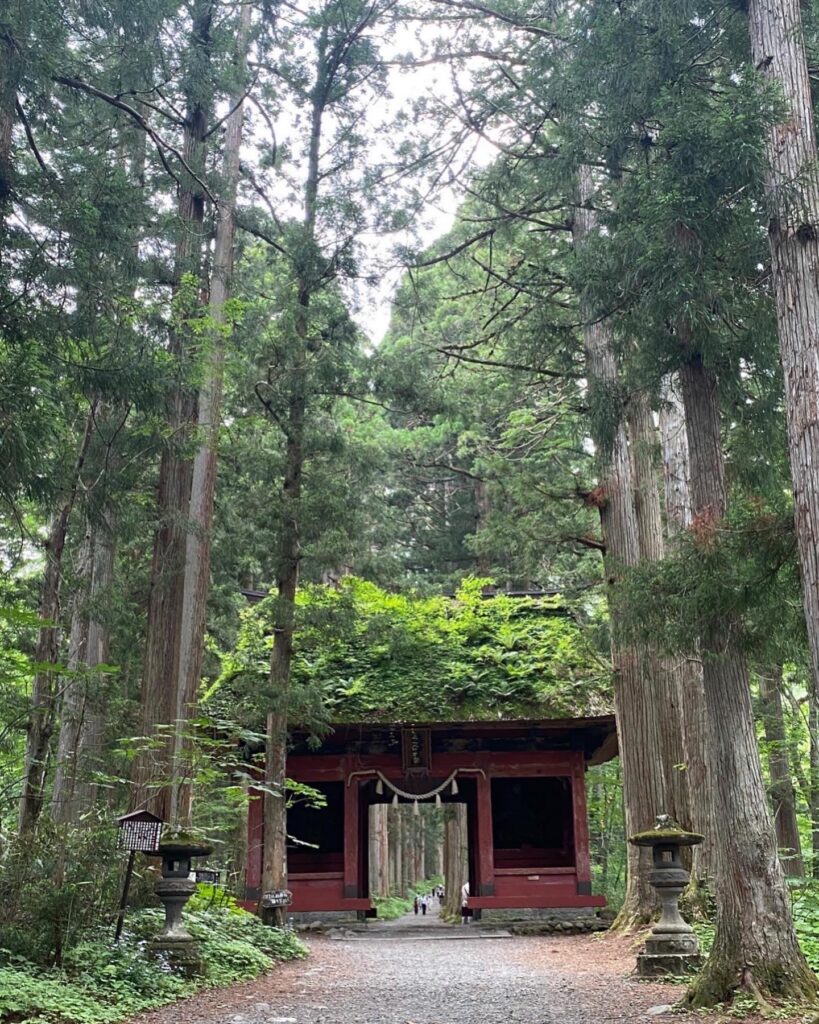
left=246, top=716, right=617, bottom=913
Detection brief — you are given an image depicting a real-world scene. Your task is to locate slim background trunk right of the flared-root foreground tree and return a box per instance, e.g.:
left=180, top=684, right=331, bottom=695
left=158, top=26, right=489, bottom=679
left=760, top=668, right=805, bottom=879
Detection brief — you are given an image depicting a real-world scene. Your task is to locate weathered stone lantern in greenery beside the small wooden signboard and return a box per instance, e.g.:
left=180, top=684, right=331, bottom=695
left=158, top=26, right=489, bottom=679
left=148, top=833, right=213, bottom=974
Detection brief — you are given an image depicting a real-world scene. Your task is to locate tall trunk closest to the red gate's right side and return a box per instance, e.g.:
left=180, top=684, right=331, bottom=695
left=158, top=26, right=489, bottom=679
left=573, top=167, right=667, bottom=929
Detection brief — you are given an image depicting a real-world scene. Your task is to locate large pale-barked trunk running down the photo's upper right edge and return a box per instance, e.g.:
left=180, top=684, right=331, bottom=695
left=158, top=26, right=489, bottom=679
left=747, top=0, right=819, bottom=729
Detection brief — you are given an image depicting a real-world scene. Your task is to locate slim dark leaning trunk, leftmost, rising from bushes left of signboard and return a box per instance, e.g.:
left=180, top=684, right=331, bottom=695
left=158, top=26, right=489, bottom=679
left=19, top=402, right=96, bottom=833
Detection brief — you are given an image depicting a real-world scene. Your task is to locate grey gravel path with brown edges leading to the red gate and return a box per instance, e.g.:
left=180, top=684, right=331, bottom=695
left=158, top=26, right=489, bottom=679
left=136, top=913, right=796, bottom=1024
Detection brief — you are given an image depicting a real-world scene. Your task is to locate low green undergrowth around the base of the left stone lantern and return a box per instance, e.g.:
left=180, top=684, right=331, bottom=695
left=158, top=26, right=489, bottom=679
left=0, top=907, right=306, bottom=1024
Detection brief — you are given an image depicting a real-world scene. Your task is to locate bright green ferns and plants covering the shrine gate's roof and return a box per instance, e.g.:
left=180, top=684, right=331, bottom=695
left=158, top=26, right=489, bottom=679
left=214, top=578, right=610, bottom=725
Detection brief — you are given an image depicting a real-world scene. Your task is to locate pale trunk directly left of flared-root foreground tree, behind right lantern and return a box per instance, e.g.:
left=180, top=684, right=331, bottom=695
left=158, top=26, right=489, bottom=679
left=659, top=377, right=717, bottom=895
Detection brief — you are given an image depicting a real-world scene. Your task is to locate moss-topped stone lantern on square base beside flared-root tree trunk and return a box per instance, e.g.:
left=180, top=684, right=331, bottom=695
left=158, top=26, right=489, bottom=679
left=629, top=814, right=702, bottom=978
